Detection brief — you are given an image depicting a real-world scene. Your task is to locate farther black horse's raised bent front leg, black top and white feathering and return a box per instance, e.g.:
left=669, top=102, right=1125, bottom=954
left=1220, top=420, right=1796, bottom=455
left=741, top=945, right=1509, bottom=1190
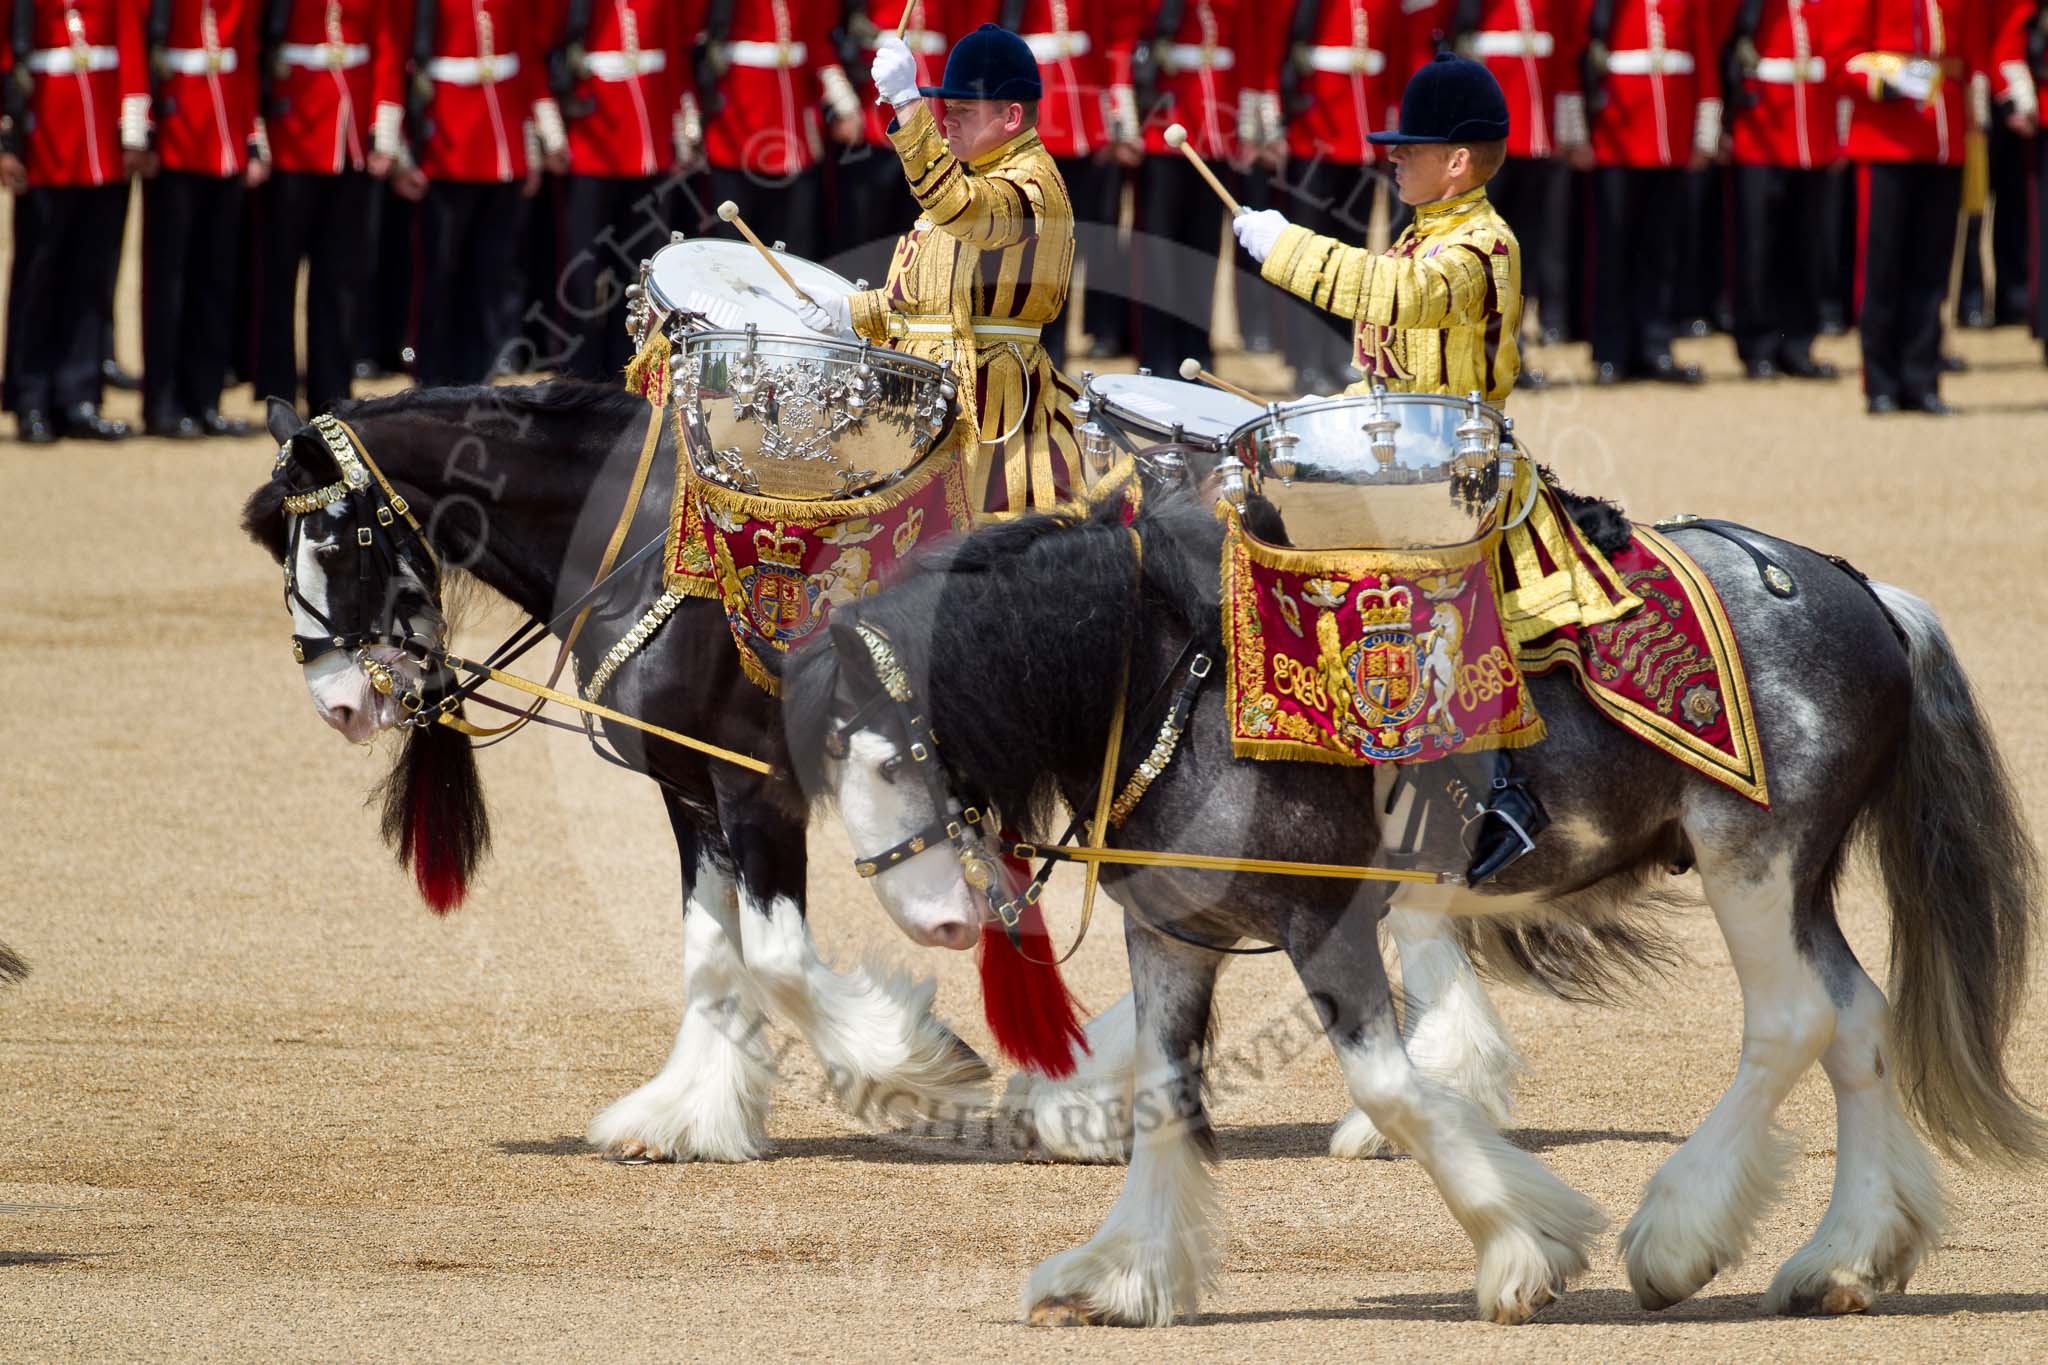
left=721, top=798, right=989, bottom=1121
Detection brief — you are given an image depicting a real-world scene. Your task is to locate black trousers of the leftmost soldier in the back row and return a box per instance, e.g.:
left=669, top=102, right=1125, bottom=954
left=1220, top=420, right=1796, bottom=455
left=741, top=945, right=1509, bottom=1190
left=6, top=180, right=129, bottom=413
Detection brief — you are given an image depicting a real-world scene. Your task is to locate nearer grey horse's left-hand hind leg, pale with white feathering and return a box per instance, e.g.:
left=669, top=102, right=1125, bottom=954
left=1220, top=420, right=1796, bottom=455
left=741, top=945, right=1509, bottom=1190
left=1620, top=831, right=1835, bottom=1310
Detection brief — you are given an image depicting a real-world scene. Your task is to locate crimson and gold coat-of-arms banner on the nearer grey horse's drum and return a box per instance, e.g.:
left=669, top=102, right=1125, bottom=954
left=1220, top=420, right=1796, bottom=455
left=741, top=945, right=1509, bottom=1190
left=1223, top=514, right=1544, bottom=763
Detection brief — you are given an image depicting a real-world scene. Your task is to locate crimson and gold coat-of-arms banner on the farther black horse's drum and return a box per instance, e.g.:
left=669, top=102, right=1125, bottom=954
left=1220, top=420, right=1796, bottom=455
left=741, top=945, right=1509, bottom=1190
left=666, top=423, right=971, bottom=696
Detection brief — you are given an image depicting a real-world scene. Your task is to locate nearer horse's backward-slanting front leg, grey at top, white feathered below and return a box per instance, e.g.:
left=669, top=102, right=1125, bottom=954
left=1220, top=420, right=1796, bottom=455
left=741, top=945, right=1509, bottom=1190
left=1286, top=909, right=1608, bottom=1326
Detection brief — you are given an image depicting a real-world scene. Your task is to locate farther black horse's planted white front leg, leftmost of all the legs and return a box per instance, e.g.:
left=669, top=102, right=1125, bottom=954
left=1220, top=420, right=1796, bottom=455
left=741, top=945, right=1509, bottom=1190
left=590, top=798, right=774, bottom=1160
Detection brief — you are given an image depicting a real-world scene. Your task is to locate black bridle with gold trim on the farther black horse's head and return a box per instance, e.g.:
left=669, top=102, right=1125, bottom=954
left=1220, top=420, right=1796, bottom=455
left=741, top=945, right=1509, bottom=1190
left=272, top=413, right=455, bottom=724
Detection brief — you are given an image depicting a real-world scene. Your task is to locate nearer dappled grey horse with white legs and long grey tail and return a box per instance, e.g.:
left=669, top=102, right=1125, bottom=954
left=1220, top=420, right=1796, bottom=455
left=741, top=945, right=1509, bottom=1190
left=784, top=497, right=2048, bottom=1324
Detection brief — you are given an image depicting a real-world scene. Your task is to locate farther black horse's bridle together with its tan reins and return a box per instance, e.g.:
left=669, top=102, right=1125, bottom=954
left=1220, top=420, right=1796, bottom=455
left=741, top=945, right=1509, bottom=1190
left=276, top=409, right=774, bottom=776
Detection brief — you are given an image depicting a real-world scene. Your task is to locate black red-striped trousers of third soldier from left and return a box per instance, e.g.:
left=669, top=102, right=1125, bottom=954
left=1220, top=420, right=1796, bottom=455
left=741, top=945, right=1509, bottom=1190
left=250, top=170, right=377, bottom=413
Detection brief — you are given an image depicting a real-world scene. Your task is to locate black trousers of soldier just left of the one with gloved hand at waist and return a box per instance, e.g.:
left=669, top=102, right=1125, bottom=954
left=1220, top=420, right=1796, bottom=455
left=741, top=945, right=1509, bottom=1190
left=1733, top=166, right=1835, bottom=364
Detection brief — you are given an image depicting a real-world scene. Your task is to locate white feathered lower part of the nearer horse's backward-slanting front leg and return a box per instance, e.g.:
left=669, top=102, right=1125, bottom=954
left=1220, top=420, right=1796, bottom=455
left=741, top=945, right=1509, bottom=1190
left=1337, top=1017, right=1608, bottom=1322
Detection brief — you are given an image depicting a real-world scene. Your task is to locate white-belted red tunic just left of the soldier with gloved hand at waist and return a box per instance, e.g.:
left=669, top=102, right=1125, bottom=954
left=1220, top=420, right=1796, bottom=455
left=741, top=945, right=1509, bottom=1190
left=1731, top=0, right=1843, bottom=170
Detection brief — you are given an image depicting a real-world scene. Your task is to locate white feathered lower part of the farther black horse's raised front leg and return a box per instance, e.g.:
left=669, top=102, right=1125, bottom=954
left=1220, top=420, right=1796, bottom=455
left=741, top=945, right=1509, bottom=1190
left=739, top=890, right=987, bottom=1124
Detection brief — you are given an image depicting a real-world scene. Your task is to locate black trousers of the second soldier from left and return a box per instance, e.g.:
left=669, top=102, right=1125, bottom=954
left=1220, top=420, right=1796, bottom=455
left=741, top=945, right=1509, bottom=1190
left=141, top=170, right=244, bottom=426
